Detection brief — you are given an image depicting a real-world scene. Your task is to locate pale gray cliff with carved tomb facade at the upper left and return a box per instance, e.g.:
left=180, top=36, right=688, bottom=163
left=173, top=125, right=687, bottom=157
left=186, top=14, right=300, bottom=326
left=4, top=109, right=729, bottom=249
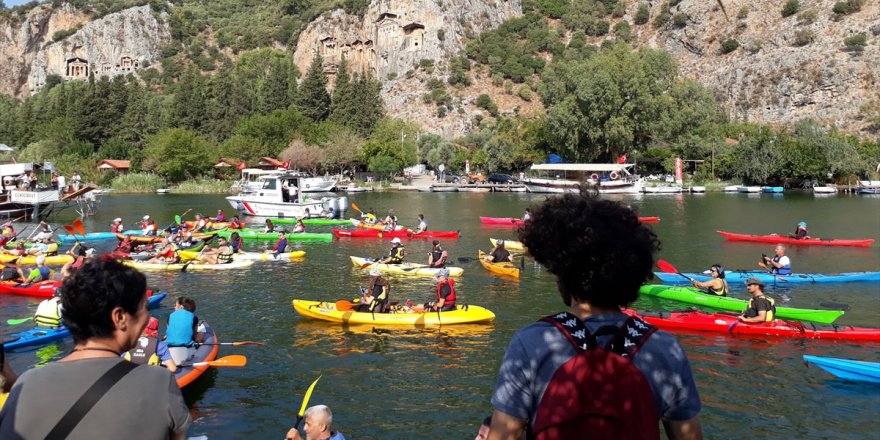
left=0, top=4, right=171, bottom=96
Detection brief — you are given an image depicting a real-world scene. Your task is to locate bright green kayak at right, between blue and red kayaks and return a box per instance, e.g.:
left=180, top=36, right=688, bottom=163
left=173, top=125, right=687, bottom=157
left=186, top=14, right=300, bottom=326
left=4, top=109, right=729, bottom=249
left=639, top=285, right=843, bottom=324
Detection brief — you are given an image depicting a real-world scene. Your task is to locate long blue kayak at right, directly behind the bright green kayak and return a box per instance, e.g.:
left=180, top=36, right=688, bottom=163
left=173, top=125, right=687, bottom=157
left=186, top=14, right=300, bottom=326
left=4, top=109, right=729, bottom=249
left=654, top=270, right=880, bottom=286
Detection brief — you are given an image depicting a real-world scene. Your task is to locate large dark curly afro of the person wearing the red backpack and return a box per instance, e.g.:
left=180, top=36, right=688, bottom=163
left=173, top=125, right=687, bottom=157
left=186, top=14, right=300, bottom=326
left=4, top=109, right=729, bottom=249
left=519, top=188, right=660, bottom=307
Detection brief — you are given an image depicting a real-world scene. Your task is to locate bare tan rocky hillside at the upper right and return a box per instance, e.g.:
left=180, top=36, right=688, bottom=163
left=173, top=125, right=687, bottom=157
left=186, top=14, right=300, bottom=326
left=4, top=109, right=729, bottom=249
left=624, top=0, right=880, bottom=133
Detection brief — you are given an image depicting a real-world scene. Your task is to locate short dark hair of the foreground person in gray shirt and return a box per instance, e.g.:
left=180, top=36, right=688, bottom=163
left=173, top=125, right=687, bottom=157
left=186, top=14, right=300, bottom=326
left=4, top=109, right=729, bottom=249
left=61, top=258, right=147, bottom=343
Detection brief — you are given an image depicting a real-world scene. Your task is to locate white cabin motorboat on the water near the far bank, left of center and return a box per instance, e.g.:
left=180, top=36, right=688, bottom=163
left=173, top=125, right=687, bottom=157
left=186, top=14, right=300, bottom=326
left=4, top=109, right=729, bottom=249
left=226, top=172, right=348, bottom=217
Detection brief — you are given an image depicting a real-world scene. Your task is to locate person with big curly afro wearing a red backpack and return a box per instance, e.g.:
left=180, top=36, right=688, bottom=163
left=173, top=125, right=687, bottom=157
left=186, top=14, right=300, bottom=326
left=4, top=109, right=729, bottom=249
left=488, top=187, right=702, bottom=440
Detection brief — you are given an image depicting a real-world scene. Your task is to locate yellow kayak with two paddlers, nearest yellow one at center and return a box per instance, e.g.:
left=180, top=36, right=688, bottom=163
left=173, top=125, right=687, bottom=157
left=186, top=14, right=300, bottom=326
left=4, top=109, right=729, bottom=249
left=293, top=299, right=495, bottom=326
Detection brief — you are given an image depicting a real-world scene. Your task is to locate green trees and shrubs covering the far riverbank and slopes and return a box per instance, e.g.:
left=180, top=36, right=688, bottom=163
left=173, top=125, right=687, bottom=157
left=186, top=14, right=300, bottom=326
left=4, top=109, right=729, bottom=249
left=0, top=0, right=880, bottom=189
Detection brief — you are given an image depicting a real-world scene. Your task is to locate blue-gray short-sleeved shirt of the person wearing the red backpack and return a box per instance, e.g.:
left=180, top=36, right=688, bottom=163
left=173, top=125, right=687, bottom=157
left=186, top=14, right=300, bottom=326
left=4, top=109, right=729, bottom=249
left=492, top=313, right=701, bottom=423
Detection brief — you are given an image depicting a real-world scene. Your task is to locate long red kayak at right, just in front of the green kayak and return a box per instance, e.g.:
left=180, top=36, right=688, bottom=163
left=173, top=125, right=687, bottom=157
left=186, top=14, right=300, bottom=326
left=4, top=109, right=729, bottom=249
left=624, top=309, right=880, bottom=342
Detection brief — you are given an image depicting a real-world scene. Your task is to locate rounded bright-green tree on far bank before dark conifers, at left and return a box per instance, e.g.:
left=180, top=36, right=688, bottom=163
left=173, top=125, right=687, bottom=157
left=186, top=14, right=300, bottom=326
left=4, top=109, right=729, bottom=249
left=143, top=128, right=216, bottom=182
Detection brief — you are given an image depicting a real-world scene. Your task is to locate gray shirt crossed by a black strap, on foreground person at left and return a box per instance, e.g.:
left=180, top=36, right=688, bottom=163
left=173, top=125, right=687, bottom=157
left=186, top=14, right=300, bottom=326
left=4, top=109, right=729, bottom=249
left=0, top=358, right=192, bottom=440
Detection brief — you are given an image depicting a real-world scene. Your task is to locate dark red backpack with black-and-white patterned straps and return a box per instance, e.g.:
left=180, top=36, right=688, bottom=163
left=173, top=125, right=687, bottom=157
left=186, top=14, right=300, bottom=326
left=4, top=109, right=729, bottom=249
left=528, top=312, right=660, bottom=440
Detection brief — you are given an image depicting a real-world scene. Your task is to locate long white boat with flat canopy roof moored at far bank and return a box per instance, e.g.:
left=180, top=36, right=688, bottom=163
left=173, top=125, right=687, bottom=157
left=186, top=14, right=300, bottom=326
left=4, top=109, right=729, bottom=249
left=523, top=163, right=645, bottom=194
